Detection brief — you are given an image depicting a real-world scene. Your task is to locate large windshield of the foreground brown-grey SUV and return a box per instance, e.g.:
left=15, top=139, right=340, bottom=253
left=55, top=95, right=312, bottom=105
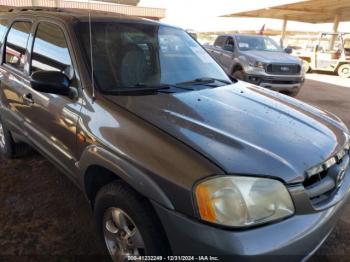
left=78, top=22, right=230, bottom=91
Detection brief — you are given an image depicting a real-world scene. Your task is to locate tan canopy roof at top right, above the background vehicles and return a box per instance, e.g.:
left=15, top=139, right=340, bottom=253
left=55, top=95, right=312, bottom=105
left=223, top=0, right=350, bottom=23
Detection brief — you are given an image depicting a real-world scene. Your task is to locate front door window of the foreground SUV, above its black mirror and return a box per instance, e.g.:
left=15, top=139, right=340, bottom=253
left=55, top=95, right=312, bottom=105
left=31, top=22, right=74, bottom=79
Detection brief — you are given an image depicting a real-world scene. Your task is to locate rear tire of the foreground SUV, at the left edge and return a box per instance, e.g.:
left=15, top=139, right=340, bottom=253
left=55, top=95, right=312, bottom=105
left=0, top=118, right=31, bottom=158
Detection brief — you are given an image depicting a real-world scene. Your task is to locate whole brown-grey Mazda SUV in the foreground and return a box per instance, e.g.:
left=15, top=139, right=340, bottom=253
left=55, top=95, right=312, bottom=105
left=0, top=8, right=350, bottom=261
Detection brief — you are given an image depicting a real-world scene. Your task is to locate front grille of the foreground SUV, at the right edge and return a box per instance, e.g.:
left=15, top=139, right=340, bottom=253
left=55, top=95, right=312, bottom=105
left=303, top=145, right=350, bottom=206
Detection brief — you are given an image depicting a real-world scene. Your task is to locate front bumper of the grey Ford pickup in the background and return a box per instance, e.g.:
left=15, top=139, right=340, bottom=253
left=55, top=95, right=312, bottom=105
left=244, top=74, right=305, bottom=92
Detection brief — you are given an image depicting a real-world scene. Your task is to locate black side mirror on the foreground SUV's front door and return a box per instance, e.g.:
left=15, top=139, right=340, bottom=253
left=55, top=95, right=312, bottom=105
left=30, top=71, right=70, bottom=96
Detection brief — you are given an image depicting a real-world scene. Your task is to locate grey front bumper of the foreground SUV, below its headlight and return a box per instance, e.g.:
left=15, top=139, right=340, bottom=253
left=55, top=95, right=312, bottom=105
left=154, top=168, right=350, bottom=261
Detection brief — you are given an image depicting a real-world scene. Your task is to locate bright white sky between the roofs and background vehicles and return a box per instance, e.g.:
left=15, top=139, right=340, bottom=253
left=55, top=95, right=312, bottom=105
left=139, top=0, right=350, bottom=32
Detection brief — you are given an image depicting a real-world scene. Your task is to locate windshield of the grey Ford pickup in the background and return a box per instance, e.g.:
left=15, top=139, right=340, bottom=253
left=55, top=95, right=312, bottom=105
left=236, top=35, right=282, bottom=52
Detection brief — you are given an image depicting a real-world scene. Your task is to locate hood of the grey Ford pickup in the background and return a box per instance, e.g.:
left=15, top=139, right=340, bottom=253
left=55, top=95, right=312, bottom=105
left=244, top=51, right=301, bottom=65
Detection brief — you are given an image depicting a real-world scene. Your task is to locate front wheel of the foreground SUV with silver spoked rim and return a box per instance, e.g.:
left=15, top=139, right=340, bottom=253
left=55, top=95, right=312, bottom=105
left=94, top=180, right=169, bottom=261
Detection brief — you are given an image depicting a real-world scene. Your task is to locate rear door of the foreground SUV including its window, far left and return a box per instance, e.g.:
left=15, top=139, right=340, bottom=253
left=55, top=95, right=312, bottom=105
left=0, top=19, right=33, bottom=137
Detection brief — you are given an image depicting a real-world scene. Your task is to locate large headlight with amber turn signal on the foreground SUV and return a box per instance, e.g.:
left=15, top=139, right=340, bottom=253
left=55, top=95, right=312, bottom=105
left=195, top=176, right=294, bottom=227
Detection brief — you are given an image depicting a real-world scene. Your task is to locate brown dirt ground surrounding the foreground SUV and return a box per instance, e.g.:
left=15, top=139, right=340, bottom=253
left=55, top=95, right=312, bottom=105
left=0, top=75, right=350, bottom=262
